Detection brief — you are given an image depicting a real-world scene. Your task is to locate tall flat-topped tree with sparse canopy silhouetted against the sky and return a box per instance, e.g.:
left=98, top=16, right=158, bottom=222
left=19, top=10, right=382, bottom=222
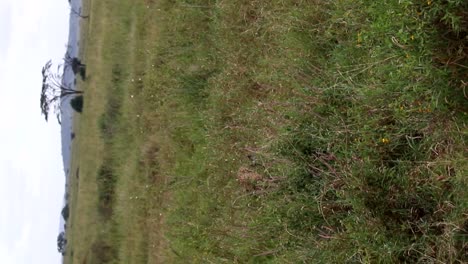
left=40, top=61, right=83, bottom=123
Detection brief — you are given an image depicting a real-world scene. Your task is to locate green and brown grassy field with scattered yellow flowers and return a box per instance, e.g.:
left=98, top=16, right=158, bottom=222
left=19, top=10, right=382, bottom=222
left=64, top=0, right=468, bottom=264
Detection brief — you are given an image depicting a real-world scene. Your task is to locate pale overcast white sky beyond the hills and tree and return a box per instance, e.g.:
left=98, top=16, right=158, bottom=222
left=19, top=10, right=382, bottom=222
left=0, top=0, right=70, bottom=264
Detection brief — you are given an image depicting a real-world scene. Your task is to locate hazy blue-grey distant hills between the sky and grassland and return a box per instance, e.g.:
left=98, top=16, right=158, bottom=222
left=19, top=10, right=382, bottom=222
left=60, top=0, right=82, bottom=231
